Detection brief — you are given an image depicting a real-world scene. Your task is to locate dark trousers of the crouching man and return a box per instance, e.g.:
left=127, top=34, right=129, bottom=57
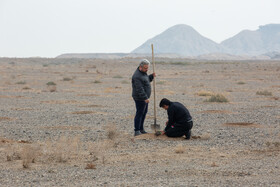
left=165, top=121, right=193, bottom=137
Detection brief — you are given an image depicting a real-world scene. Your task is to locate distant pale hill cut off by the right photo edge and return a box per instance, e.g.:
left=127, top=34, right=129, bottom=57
left=221, top=24, right=280, bottom=55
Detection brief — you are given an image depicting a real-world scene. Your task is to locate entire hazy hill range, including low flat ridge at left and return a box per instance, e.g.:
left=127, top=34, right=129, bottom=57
left=57, top=24, right=280, bottom=60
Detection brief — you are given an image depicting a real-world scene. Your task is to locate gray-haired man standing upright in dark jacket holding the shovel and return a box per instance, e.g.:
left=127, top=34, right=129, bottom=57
left=131, top=59, right=156, bottom=136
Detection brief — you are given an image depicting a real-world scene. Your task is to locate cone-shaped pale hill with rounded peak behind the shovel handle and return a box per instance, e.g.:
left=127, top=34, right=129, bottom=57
left=132, top=24, right=227, bottom=56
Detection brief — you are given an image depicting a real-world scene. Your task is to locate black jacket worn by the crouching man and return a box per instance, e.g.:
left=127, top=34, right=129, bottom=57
left=166, top=102, right=192, bottom=129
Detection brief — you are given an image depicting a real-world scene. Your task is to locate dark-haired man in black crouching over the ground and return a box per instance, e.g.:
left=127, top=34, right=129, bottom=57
left=159, top=98, right=193, bottom=139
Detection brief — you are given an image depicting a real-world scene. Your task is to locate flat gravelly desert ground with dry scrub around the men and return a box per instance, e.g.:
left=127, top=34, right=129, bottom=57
left=0, top=58, right=280, bottom=186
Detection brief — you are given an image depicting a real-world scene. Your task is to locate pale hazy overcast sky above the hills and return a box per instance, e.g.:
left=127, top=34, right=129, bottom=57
left=0, top=0, right=280, bottom=57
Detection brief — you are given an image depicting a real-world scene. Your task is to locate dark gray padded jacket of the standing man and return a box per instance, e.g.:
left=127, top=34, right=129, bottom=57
left=131, top=67, right=154, bottom=101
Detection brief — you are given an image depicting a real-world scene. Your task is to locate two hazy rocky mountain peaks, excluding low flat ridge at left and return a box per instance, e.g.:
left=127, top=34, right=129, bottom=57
left=132, top=24, right=280, bottom=58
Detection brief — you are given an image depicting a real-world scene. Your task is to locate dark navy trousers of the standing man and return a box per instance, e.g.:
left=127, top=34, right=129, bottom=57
left=134, top=100, right=148, bottom=131
